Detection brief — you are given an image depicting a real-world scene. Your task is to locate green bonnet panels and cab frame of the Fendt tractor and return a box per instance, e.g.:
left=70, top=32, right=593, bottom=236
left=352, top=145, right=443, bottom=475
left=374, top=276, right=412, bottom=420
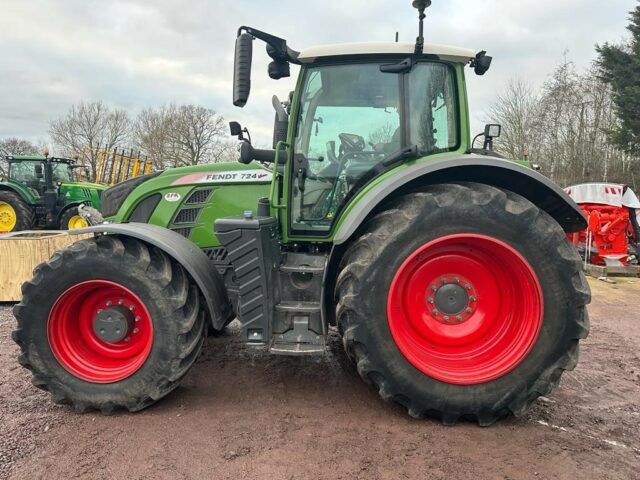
left=108, top=62, right=528, bottom=248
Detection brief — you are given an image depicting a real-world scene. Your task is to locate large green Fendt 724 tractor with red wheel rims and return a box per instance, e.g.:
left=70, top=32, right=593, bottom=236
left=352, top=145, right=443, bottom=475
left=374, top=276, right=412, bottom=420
left=13, top=0, right=590, bottom=425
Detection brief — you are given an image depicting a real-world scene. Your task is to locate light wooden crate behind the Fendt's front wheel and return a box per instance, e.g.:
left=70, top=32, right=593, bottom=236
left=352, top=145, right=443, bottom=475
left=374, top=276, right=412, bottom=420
left=0, top=230, right=91, bottom=302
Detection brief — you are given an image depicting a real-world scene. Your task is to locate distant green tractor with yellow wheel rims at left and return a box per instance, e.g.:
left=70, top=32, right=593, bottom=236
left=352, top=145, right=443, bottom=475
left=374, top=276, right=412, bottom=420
left=0, top=155, right=107, bottom=233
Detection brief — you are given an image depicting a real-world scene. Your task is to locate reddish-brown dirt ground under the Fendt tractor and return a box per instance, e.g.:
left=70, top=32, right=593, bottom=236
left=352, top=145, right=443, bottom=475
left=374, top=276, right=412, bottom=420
left=0, top=279, right=640, bottom=480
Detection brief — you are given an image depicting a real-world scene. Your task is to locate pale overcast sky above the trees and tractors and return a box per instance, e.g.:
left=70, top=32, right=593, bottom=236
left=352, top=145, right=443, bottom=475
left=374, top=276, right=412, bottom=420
left=0, top=0, right=637, bottom=149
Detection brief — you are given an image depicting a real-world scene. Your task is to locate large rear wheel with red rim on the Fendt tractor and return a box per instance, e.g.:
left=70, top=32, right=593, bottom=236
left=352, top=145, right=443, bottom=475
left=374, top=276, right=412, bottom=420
left=336, top=183, right=590, bottom=425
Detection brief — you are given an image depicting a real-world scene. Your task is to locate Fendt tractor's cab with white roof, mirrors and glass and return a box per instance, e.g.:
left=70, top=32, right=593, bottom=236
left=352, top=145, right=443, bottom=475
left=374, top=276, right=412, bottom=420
left=231, top=2, right=499, bottom=239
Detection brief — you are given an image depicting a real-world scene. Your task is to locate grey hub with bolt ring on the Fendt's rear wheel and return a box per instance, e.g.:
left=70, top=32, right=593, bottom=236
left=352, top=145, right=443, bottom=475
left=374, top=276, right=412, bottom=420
left=427, top=275, right=477, bottom=323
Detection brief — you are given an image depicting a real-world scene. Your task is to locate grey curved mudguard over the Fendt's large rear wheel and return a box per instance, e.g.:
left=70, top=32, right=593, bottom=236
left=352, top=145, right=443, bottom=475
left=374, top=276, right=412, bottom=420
left=334, top=155, right=587, bottom=245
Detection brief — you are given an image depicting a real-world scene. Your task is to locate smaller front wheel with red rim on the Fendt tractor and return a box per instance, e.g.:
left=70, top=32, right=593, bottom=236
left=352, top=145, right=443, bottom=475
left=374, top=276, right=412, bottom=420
left=13, top=235, right=205, bottom=414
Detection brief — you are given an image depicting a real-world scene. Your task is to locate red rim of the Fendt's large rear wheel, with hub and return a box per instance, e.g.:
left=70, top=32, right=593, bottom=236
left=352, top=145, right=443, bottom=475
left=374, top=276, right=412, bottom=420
left=387, top=234, right=544, bottom=385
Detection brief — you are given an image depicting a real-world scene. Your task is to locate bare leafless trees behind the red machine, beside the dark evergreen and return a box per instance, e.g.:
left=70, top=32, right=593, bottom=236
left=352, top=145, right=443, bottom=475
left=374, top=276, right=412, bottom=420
left=490, top=55, right=640, bottom=188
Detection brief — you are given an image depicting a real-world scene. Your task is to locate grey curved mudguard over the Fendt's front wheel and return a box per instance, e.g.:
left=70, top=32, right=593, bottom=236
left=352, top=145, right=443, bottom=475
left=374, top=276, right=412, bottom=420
left=69, top=223, right=232, bottom=330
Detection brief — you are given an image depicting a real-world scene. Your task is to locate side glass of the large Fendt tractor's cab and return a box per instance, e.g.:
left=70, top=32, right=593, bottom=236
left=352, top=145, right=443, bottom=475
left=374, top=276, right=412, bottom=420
left=290, top=62, right=459, bottom=232
